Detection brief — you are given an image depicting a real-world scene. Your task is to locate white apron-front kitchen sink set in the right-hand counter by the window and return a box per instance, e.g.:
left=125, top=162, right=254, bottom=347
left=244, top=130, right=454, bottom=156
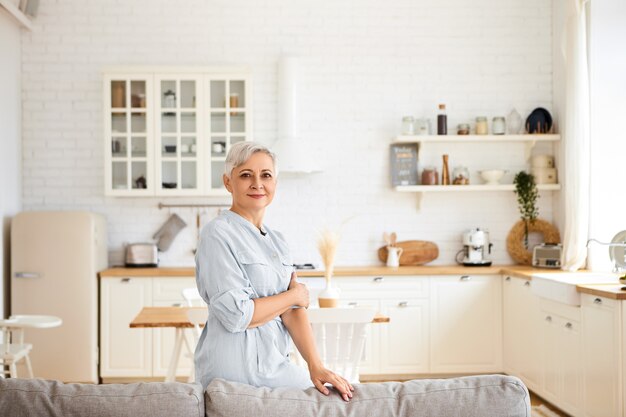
left=531, top=272, right=619, bottom=306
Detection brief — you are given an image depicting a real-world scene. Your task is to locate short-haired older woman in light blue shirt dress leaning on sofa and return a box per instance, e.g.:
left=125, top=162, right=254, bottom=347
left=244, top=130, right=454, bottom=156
left=195, top=142, right=353, bottom=401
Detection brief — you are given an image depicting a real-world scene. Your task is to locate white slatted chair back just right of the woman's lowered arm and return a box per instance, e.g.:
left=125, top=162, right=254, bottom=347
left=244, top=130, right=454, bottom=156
left=296, top=308, right=376, bottom=383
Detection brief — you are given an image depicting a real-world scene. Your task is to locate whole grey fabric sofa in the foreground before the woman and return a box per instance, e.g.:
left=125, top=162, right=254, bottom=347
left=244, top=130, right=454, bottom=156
left=0, top=375, right=530, bottom=417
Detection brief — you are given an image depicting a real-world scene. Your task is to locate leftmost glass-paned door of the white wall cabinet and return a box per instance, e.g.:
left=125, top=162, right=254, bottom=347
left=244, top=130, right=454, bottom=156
left=104, top=74, right=154, bottom=196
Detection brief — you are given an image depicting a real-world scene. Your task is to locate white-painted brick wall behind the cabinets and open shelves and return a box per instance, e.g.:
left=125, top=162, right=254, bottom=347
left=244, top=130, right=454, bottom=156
left=22, top=0, right=553, bottom=265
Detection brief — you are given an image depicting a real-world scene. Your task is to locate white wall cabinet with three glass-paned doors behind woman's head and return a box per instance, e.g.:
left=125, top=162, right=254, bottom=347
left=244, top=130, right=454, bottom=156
left=104, top=68, right=252, bottom=197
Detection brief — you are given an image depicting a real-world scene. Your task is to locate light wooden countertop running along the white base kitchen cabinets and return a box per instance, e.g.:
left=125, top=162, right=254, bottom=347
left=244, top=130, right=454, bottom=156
left=99, top=265, right=626, bottom=300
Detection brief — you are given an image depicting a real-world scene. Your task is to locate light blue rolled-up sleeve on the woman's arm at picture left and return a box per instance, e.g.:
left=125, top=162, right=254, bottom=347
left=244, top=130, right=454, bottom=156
left=196, top=224, right=256, bottom=333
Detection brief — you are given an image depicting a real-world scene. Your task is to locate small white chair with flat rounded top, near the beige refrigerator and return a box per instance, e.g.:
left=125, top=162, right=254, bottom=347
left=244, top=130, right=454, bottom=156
left=0, top=315, right=63, bottom=378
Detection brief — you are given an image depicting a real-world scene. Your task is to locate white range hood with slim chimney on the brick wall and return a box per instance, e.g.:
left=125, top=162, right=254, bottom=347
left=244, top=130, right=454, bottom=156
left=271, top=57, right=322, bottom=174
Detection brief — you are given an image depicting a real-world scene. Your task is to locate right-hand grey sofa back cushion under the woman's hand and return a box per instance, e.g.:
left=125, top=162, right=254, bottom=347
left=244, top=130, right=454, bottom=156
left=204, top=375, right=530, bottom=417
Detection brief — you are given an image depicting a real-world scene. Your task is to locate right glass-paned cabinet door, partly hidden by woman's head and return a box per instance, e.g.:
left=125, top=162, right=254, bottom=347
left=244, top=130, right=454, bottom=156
left=204, top=74, right=251, bottom=194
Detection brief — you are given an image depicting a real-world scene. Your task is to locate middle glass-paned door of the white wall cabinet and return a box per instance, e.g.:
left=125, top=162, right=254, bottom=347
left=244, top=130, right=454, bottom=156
left=154, top=74, right=204, bottom=195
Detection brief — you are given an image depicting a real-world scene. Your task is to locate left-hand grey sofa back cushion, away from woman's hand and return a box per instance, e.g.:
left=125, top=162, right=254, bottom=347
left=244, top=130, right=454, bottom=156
left=0, top=378, right=204, bottom=417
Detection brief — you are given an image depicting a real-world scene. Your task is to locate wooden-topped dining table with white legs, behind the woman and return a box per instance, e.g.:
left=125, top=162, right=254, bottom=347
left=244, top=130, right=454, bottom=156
left=130, top=306, right=389, bottom=382
